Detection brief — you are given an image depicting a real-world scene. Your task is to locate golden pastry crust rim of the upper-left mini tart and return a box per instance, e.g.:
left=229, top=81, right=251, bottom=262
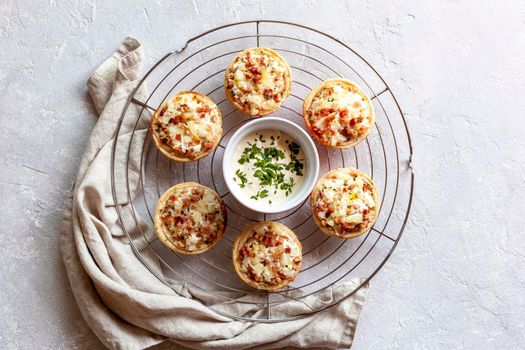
left=150, top=91, right=222, bottom=162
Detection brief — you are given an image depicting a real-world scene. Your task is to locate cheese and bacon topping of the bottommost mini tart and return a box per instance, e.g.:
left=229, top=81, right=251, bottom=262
left=237, top=224, right=301, bottom=286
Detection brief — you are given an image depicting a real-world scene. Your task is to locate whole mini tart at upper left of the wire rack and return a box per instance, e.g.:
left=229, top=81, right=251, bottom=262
left=150, top=91, right=222, bottom=162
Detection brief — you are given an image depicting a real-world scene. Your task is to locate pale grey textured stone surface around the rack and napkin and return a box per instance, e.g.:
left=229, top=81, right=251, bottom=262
left=0, top=0, right=525, bottom=349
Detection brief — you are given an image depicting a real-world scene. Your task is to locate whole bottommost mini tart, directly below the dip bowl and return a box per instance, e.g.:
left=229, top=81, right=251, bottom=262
left=232, top=221, right=302, bottom=291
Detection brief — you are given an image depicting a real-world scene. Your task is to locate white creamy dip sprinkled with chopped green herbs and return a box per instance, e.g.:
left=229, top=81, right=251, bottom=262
left=232, top=130, right=307, bottom=205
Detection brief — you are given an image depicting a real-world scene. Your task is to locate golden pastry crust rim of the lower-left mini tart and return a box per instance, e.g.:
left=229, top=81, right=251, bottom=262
left=153, top=182, right=227, bottom=255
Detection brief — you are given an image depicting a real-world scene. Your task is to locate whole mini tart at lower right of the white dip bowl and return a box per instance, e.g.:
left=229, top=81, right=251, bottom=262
left=310, top=168, right=380, bottom=238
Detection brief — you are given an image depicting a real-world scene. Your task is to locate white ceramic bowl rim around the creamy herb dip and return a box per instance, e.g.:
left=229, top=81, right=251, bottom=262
left=222, top=117, right=319, bottom=214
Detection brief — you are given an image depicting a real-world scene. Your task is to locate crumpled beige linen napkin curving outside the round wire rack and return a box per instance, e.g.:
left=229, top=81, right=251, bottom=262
left=60, top=38, right=368, bottom=349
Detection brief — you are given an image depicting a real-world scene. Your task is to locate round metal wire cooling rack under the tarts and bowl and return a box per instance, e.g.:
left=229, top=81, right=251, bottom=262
left=111, top=20, right=414, bottom=322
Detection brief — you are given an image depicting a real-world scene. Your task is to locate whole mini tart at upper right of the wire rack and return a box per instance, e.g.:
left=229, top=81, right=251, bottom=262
left=303, top=79, right=375, bottom=148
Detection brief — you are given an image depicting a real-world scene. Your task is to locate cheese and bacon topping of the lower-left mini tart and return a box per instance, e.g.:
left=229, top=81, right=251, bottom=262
left=160, top=186, right=225, bottom=252
